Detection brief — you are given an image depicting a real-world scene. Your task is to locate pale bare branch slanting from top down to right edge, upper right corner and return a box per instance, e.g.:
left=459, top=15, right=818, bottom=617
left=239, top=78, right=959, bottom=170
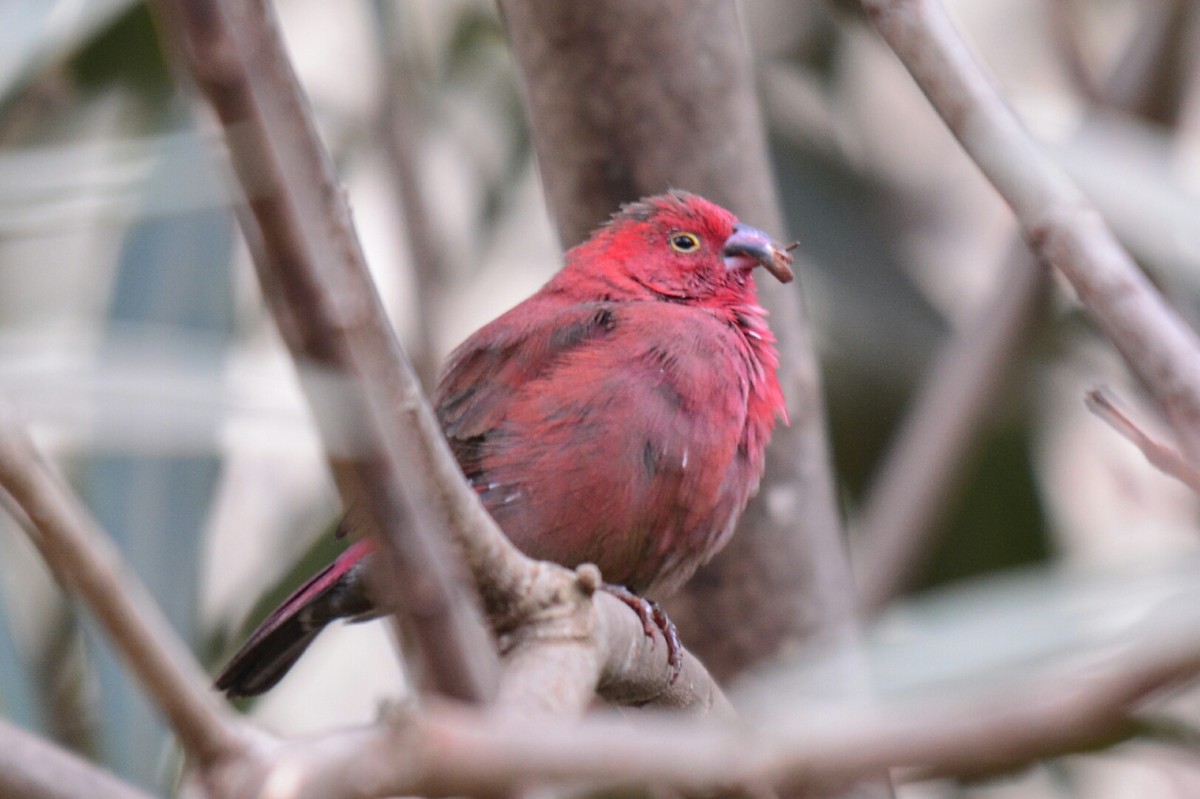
left=864, top=0, right=1200, bottom=455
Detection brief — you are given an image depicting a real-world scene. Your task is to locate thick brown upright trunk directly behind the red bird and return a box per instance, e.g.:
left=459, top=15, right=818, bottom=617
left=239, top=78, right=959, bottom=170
left=499, top=7, right=890, bottom=795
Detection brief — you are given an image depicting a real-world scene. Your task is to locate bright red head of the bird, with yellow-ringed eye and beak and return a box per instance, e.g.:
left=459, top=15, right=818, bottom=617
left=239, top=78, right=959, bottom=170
left=568, top=191, right=792, bottom=301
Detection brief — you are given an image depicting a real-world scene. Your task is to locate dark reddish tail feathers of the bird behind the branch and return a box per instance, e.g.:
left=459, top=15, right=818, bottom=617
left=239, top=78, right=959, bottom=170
left=216, top=540, right=374, bottom=697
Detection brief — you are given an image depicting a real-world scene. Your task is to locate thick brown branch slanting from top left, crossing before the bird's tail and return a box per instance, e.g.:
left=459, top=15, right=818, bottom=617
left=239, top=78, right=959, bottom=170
left=147, top=0, right=499, bottom=701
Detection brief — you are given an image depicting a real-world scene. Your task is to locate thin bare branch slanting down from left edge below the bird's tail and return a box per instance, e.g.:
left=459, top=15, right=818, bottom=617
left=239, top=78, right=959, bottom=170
left=0, top=409, right=246, bottom=764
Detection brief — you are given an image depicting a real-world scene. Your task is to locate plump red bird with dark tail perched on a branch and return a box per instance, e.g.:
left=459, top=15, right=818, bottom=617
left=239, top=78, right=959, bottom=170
left=216, top=192, right=792, bottom=696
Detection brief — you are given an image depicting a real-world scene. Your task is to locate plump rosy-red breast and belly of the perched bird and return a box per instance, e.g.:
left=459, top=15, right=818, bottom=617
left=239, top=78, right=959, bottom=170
left=476, top=298, right=762, bottom=590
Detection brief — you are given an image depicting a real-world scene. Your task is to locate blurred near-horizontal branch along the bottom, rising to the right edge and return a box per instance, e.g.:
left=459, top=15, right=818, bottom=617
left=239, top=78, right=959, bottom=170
left=236, top=609, right=1200, bottom=799
